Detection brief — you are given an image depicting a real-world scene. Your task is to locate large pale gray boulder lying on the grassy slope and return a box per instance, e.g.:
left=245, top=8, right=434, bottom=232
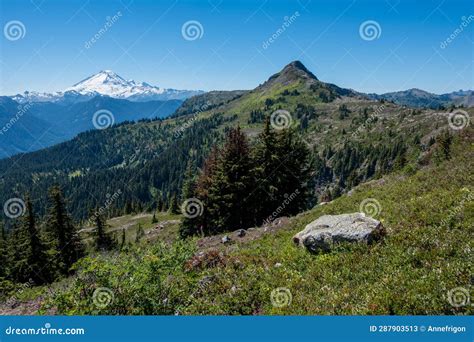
left=293, top=213, right=385, bottom=253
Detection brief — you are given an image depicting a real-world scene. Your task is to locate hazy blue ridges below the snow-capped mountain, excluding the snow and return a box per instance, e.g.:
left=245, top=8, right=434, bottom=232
left=0, top=96, right=182, bottom=159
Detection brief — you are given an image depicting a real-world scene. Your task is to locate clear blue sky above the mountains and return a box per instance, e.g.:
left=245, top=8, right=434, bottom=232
left=0, top=0, right=474, bottom=95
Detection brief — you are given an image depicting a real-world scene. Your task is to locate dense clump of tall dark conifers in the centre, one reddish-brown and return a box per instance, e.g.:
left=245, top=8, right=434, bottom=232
left=180, top=119, right=312, bottom=237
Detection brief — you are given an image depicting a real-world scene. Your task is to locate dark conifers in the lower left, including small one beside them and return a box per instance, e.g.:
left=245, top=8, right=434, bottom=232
left=0, top=186, right=116, bottom=288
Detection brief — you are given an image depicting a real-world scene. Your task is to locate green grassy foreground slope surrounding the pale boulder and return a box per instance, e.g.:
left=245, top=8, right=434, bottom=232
left=45, top=131, right=474, bottom=315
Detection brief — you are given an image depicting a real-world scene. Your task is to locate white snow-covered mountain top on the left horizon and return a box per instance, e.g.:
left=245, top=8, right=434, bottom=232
left=11, top=70, right=203, bottom=103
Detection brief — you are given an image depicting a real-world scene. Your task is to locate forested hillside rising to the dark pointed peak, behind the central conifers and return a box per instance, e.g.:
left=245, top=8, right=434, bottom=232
left=0, top=62, right=460, bottom=219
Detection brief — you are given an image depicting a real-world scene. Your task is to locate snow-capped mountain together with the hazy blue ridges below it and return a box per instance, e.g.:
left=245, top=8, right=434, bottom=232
left=0, top=70, right=204, bottom=158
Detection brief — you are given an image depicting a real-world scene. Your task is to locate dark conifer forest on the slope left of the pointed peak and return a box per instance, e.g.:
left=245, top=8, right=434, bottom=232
left=0, top=115, right=234, bottom=222
